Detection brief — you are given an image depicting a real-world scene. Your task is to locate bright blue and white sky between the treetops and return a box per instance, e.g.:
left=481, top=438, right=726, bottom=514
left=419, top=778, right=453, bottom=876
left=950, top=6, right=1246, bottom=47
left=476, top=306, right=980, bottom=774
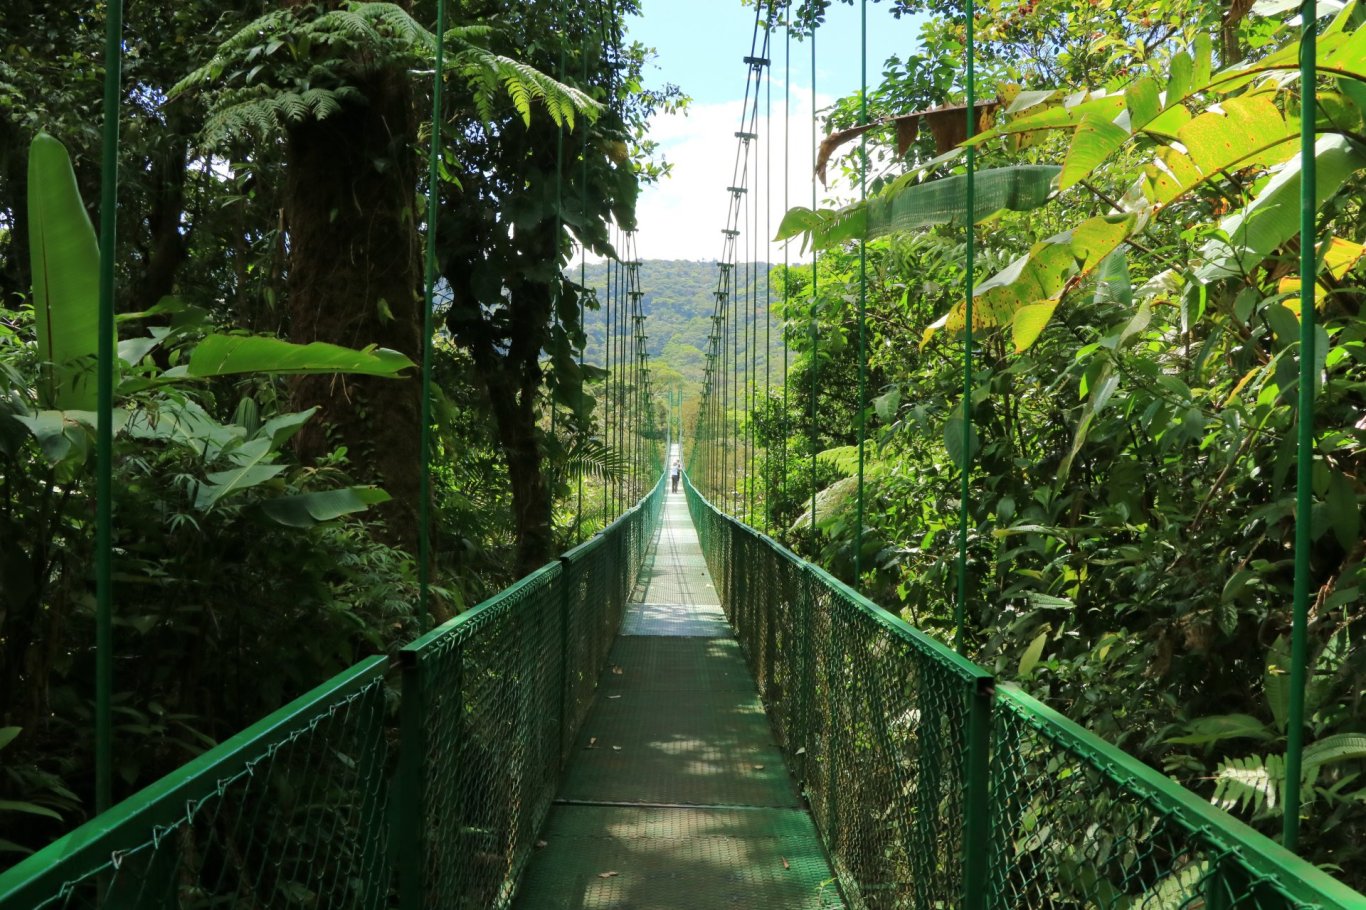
left=627, top=0, right=919, bottom=261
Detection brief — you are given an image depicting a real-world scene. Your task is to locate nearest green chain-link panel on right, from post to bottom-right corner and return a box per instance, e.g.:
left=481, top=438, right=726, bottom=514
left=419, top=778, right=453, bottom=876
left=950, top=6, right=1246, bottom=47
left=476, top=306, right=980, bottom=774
left=989, top=686, right=1366, bottom=910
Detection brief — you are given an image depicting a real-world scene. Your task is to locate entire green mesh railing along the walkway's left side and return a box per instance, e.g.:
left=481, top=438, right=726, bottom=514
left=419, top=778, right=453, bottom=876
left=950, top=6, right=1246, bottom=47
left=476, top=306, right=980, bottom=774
left=0, top=481, right=664, bottom=910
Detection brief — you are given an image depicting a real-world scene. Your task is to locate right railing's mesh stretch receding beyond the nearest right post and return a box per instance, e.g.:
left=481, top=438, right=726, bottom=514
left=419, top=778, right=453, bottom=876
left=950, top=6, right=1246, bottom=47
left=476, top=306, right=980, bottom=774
left=688, top=475, right=990, bottom=909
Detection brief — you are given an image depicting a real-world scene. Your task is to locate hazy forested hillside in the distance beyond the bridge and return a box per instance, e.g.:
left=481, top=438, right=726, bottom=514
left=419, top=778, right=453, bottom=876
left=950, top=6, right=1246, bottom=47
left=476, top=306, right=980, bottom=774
left=572, top=260, right=781, bottom=396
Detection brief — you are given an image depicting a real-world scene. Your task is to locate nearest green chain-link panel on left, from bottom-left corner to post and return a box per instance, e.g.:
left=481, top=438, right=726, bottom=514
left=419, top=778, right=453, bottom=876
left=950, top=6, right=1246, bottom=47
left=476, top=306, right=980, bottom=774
left=0, top=657, right=392, bottom=910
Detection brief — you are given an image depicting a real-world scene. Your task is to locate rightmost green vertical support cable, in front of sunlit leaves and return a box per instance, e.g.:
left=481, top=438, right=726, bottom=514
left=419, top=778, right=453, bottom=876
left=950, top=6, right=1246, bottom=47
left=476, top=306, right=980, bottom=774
left=1281, top=0, right=1318, bottom=850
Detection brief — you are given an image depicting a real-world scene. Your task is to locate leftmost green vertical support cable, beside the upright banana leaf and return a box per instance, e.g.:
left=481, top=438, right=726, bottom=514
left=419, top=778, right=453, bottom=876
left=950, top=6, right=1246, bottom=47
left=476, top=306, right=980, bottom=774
left=94, top=0, right=123, bottom=812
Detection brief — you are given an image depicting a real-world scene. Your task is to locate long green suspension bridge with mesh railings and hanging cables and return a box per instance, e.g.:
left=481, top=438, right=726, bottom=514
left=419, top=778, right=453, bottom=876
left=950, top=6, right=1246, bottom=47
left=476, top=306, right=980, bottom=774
left=0, top=4, right=1366, bottom=910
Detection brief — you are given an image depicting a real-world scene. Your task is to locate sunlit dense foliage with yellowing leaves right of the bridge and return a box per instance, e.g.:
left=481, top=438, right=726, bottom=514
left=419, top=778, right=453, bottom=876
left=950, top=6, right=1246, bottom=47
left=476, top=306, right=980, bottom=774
left=695, top=0, right=1366, bottom=888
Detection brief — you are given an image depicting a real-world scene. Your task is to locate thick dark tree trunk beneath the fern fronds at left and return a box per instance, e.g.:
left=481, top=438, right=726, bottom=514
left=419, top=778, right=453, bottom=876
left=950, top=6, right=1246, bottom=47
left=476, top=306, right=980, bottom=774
left=284, top=70, right=422, bottom=552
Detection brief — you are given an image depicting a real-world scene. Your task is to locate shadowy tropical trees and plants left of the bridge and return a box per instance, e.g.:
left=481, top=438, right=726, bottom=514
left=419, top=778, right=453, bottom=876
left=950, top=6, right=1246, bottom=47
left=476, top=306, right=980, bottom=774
left=0, top=0, right=663, bottom=862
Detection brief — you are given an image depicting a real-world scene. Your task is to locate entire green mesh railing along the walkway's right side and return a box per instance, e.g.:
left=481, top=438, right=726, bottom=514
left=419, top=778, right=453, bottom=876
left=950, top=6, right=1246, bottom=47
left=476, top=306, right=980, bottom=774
left=686, top=470, right=1366, bottom=910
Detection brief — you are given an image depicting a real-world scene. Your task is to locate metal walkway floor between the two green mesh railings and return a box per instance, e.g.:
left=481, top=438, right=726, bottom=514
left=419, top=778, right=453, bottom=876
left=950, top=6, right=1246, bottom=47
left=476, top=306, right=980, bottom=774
left=515, top=492, right=844, bottom=910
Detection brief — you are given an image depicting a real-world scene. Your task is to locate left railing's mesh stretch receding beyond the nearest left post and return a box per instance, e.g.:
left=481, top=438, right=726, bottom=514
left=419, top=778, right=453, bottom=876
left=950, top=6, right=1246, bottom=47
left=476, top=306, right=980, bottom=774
left=395, top=480, right=664, bottom=910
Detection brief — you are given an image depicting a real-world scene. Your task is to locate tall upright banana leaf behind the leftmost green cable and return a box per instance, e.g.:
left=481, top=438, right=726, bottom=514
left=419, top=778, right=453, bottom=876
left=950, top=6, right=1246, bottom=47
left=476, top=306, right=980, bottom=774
left=29, top=133, right=100, bottom=411
